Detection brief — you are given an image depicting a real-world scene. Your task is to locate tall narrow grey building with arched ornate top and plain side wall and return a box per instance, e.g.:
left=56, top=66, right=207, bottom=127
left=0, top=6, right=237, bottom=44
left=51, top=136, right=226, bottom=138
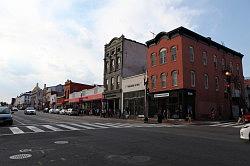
left=103, top=35, right=147, bottom=114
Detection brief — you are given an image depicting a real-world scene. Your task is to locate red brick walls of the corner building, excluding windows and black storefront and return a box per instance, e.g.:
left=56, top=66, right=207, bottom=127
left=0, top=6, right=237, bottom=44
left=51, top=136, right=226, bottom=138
left=147, top=27, right=244, bottom=119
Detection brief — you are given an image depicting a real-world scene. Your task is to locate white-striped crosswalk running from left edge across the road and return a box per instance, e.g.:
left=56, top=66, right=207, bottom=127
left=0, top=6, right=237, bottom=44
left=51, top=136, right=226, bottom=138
left=0, top=123, right=181, bottom=136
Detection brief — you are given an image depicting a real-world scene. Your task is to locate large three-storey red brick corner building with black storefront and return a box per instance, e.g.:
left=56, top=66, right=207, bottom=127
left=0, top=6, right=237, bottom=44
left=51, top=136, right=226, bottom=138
left=146, top=27, right=244, bottom=119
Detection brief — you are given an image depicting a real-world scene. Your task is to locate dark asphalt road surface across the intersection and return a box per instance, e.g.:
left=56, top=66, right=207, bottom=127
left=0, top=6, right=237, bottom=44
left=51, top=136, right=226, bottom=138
left=0, top=111, right=250, bottom=166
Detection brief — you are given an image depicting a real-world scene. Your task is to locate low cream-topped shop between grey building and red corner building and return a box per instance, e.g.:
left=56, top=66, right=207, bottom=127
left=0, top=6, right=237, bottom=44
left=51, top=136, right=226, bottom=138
left=122, top=73, right=146, bottom=116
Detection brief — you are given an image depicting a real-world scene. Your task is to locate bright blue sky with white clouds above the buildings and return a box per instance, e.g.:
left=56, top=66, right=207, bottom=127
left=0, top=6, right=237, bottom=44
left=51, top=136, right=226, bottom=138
left=0, top=0, right=250, bottom=102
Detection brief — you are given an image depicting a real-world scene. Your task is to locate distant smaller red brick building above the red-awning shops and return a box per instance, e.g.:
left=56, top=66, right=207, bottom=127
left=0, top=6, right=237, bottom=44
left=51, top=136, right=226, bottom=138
left=64, top=80, right=95, bottom=99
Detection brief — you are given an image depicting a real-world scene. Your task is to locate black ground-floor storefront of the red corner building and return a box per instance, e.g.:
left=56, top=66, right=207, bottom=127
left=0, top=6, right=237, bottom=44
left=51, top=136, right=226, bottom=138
left=148, top=89, right=196, bottom=119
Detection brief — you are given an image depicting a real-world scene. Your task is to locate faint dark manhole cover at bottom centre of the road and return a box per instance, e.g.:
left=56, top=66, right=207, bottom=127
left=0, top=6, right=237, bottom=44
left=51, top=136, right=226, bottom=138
left=107, top=155, right=151, bottom=164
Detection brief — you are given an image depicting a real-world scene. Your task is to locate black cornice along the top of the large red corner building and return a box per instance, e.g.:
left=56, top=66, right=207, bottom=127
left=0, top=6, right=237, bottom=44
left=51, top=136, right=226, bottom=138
left=146, top=26, right=244, bottom=58
